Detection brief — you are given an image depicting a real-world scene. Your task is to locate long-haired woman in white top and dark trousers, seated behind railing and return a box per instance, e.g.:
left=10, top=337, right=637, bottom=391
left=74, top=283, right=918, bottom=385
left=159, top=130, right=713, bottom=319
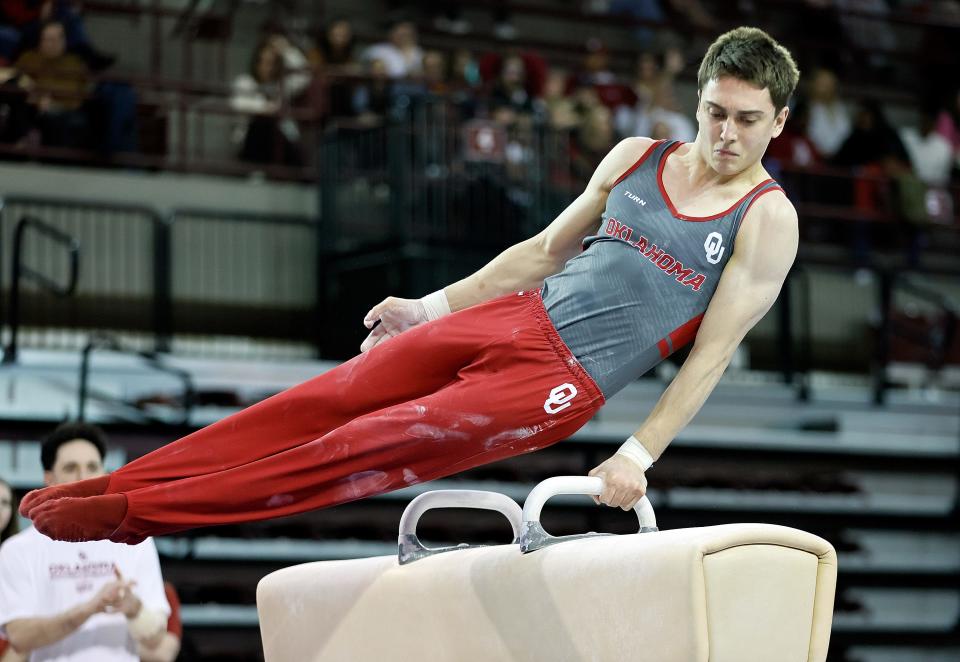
left=230, top=34, right=310, bottom=165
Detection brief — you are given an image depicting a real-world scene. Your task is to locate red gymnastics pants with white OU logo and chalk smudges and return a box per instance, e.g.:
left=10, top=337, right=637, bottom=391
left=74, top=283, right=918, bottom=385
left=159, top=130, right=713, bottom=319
left=106, top=291, right=604, bottom=539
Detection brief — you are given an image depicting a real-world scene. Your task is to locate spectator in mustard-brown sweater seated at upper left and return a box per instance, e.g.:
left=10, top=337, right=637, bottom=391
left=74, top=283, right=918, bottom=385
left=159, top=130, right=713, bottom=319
left=15, top=21, right=93, bottom=147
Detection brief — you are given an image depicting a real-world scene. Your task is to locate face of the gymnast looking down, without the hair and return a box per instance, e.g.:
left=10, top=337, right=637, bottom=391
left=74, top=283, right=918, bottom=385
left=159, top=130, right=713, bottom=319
left=697, top=76, right=789, bottom=175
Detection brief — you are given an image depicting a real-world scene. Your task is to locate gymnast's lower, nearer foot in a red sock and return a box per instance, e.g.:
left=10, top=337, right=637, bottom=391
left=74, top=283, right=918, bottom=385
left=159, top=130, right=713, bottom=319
left=31, top=494, right=127, bottom=544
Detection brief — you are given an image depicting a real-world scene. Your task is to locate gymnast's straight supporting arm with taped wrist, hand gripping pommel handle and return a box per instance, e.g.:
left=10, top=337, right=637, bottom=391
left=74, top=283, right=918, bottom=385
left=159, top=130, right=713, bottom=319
left=590, top=191, right=799, bottom=510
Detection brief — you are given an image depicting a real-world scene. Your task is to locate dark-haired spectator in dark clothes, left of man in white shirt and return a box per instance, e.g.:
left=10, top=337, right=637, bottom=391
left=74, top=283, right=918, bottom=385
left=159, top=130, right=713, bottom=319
left=307, top=19, right=363, bottom=117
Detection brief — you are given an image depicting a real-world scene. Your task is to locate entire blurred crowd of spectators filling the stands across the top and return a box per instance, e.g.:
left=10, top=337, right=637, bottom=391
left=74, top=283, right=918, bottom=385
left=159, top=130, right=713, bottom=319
left=0, top=0, right=960, bottom=206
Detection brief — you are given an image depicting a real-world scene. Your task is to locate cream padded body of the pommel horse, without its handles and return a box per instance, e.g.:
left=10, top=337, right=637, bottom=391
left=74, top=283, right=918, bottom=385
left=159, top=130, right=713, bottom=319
left=257, top=524, right=837, bottom=662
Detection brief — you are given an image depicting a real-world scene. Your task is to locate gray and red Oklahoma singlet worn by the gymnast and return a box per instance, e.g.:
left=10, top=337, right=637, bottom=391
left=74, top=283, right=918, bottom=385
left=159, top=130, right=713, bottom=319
left=542, top=141, right=780, bottom=398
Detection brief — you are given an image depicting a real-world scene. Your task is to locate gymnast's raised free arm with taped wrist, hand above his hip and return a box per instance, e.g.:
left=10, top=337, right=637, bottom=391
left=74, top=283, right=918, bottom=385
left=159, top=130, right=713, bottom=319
left=360, top=138, right=652, bottom=352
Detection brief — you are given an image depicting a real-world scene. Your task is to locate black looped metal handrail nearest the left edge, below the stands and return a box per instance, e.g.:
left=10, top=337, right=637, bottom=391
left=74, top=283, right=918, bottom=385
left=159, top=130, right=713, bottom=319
left=3, top=216, right=80, bottom=364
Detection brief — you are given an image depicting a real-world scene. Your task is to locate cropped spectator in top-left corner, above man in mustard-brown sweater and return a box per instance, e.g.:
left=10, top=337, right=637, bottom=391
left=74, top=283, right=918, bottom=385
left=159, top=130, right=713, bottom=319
left=0, top=0, right=116, bottom=71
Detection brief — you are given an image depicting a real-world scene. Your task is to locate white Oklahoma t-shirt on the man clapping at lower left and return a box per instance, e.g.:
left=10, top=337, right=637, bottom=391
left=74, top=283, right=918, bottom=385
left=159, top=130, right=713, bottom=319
left=0, top=527, right=170, bottom=662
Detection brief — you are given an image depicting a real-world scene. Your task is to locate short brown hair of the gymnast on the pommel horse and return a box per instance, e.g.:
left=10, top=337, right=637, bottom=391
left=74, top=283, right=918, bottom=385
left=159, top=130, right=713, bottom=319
left=697, top=27, right=800, bottom=111
